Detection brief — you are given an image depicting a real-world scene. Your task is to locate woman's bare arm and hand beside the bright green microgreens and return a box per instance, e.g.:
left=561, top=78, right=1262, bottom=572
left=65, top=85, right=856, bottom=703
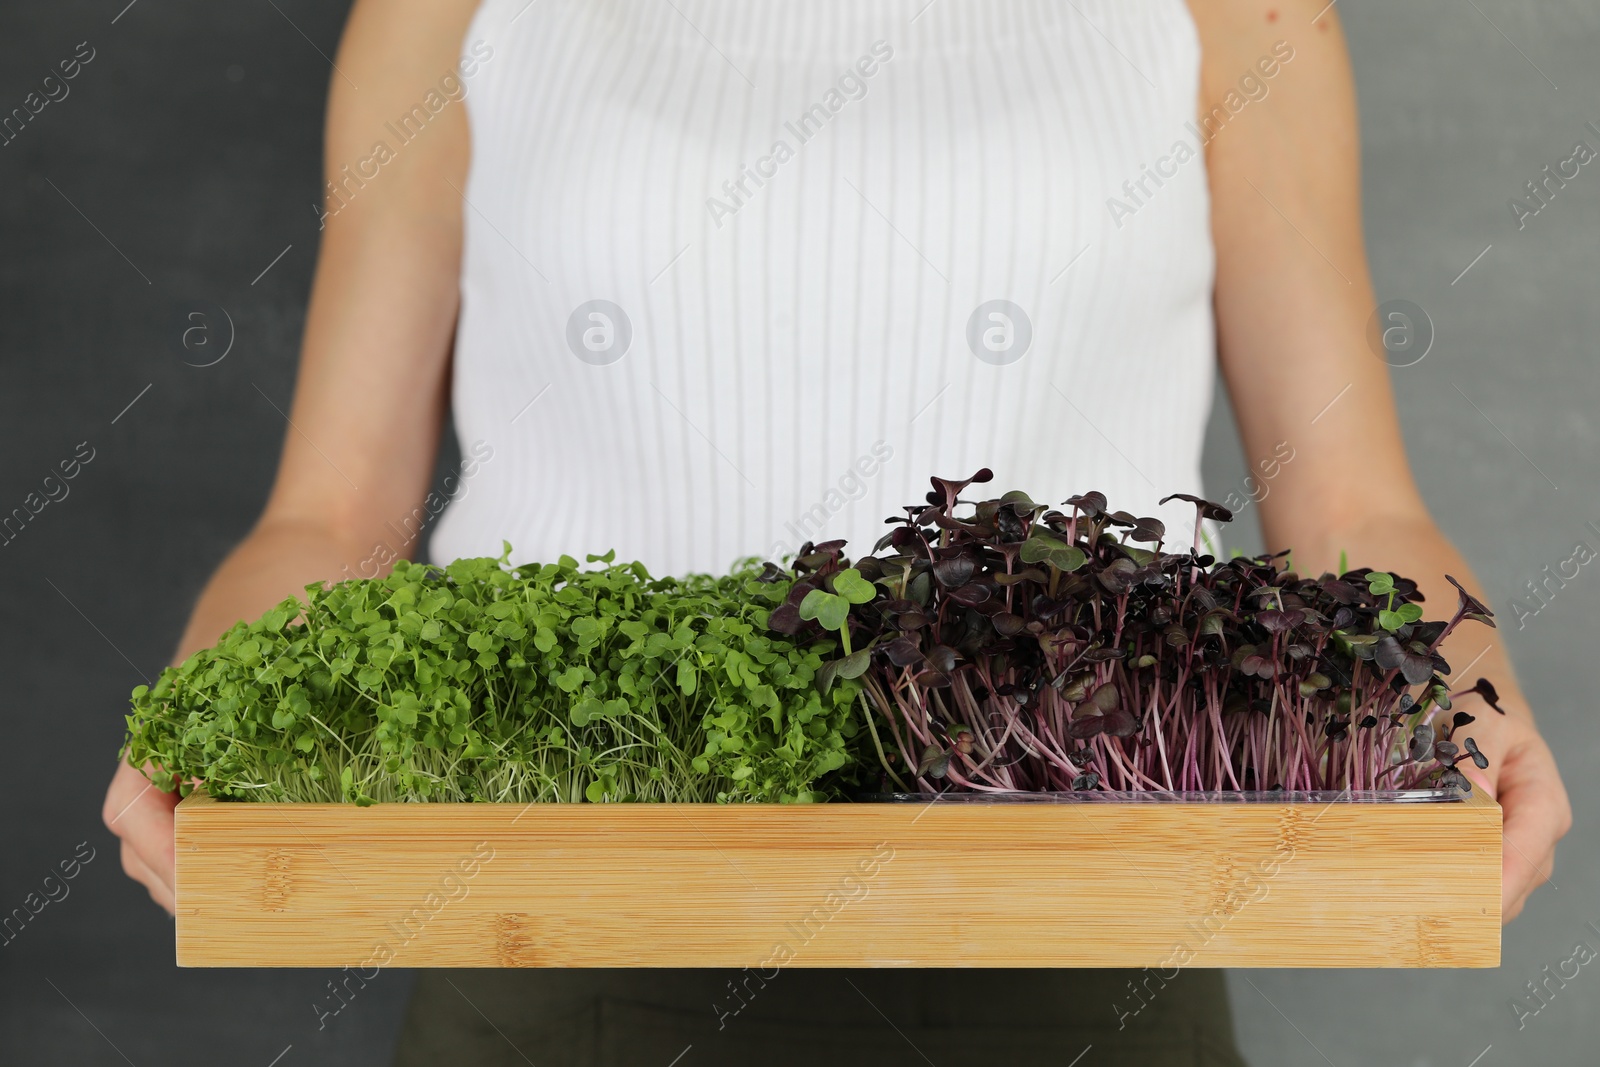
left=104, top=0, right=477, bottom=910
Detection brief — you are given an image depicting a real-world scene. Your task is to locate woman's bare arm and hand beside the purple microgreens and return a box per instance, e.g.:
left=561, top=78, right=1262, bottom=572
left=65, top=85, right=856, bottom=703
left=1190, top=0, right=1571, bottom=920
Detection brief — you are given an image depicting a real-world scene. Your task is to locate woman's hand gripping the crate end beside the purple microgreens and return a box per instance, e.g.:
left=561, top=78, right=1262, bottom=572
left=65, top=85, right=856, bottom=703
left=1456, top=697, right=1573, bottom=923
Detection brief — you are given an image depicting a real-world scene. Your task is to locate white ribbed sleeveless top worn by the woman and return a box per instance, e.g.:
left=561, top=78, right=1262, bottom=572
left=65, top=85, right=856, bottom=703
left=432, top=0, right=1214, bottom=574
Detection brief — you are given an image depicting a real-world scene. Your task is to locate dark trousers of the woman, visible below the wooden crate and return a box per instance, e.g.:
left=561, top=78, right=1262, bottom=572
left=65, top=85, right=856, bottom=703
left=395, top=968, right=1245, bottom=1067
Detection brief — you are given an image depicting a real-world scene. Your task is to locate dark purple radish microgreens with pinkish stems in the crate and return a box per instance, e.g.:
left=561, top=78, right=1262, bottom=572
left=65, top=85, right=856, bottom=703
left=773, top=470, right=1494, bottom=792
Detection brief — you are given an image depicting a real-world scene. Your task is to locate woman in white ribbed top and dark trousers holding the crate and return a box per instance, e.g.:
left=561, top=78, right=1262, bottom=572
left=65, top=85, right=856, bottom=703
left=106, top=0, right=1570, bottom=1064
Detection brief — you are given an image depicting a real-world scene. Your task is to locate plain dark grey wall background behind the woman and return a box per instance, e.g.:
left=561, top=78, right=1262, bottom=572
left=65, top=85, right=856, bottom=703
left=0, top=0, right=1600, bottom=1067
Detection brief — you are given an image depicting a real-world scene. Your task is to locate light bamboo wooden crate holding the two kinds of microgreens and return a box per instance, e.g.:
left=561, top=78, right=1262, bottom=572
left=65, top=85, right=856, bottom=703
left=178, top=792, right=1501, bottom=969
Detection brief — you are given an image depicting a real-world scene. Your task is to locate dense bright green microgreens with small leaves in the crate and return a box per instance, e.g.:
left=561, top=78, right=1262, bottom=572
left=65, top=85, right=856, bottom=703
left=126, top=545, right=870, bottom=803
